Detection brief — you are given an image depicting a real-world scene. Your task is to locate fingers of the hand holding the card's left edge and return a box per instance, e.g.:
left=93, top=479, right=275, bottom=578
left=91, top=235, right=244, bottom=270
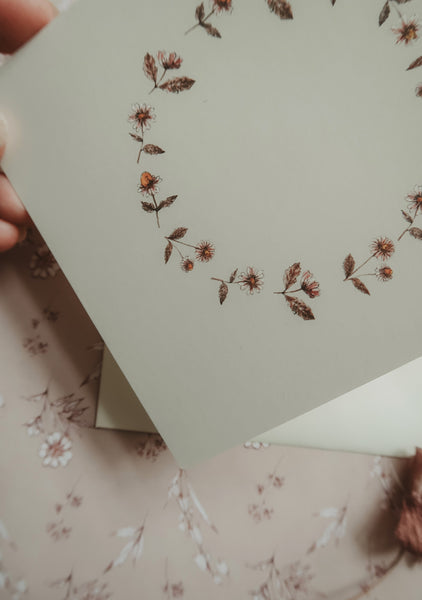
left=0, top=0, right=57, bottom=252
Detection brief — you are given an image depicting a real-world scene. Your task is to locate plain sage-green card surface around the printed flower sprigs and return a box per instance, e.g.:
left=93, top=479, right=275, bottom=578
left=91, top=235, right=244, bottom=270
left=0, top=0, right=422, bottom=466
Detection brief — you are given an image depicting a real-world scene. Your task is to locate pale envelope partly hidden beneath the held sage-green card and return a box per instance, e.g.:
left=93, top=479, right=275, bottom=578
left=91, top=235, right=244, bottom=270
left=96, top=348, right=422, bottom=457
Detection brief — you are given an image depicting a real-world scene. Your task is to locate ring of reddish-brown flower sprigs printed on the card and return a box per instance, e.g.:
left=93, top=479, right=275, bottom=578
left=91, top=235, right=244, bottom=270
left=128, top=0, right=422, bottom=321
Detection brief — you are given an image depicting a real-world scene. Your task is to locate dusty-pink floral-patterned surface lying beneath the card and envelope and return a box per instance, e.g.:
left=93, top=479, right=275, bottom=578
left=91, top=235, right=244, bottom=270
left=0, top=227, right=422, bottom=600
